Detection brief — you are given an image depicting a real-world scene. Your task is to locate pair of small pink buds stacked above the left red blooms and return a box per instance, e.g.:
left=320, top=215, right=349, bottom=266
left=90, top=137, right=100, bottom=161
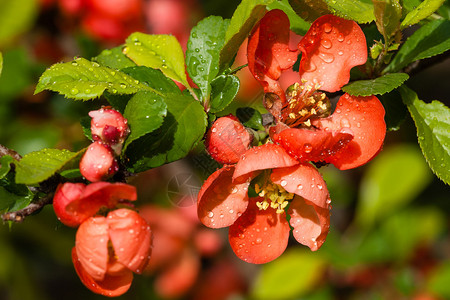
left=80, top=107, right=129, bottom=182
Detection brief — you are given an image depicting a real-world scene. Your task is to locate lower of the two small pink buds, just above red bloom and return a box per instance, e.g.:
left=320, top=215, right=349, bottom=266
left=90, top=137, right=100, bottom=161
left=80, top=141, right=119, bottom=182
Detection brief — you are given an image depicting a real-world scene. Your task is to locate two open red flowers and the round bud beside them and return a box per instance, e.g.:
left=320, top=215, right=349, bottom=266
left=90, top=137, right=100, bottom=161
left=198, top=10, right=386, bottom=263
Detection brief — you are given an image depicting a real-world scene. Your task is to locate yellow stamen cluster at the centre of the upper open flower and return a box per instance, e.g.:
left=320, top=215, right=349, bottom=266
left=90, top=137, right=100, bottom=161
left=281, top=82, right=331, bottom=127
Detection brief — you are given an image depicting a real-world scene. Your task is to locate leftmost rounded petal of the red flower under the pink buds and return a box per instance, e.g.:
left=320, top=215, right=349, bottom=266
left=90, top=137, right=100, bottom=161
left=53, top=182, right=86, bottom=227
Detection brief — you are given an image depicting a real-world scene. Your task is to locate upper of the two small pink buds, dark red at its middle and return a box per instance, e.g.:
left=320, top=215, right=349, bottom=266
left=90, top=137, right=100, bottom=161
left=89, top=108, right=129, bottom=155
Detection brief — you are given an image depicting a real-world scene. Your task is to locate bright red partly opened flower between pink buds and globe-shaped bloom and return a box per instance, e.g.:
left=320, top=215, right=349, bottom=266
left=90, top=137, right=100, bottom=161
left=53, top=182, right=137, bottom=227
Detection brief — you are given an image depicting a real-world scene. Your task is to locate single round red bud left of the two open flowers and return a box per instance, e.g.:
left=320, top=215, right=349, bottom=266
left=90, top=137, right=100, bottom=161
left=205, top=115, right=252, bottom=164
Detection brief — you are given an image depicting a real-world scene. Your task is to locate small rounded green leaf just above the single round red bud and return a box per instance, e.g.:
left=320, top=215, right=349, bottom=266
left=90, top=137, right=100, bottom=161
left=209, top=75, right=240, bottom=113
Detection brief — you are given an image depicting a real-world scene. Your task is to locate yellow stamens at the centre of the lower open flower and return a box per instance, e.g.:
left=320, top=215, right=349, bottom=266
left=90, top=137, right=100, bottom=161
left=255, top=182, right=294, bottom=214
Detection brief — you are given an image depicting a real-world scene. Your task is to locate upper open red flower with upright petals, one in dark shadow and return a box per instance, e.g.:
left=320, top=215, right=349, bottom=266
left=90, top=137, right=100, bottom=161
left=248, top=10, right=386, bottom=169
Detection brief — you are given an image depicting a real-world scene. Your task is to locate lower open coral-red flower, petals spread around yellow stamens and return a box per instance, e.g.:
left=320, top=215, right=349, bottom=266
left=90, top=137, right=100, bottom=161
left=198, top=144, right=330, bottom=264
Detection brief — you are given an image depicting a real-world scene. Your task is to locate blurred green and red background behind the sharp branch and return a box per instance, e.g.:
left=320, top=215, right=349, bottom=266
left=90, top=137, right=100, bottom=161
left=0, top=0, right=450, bottom=300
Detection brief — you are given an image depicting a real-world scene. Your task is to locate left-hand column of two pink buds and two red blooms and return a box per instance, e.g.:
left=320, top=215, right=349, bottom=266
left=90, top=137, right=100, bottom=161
left=53, top=108, right=152, bottom=297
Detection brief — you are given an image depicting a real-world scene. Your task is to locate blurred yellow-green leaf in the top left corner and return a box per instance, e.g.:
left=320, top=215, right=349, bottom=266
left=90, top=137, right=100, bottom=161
left=0, top=0, right=38, bottom=46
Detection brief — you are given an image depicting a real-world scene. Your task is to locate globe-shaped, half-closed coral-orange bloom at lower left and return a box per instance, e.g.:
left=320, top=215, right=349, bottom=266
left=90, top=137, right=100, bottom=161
left=72, top=208, right=151, bottom=297
